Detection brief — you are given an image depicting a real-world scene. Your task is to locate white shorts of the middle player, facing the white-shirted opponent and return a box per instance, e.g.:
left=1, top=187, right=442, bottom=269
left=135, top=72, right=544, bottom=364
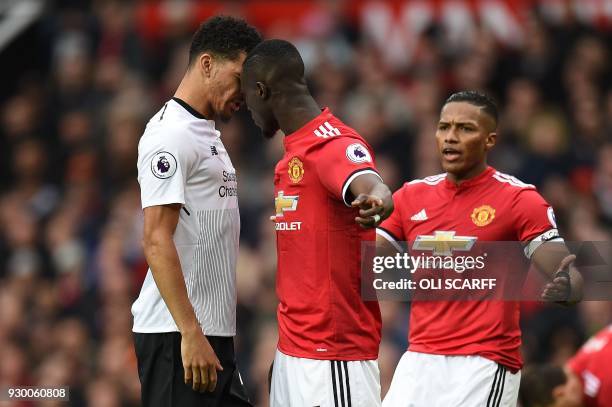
left=270, top=350, right=381, bottom=407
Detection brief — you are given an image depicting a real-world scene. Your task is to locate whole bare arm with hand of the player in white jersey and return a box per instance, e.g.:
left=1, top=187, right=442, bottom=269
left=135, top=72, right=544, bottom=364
left=143, top=204, right=223, bottom=392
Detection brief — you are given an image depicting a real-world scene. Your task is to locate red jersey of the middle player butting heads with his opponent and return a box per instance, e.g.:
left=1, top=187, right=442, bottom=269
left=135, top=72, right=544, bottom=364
left=274, top=109, right=381, bottom=360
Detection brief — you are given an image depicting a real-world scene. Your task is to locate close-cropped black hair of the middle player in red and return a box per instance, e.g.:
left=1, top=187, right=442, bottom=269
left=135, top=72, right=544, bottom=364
left=243, top=39, right=304, bottom=81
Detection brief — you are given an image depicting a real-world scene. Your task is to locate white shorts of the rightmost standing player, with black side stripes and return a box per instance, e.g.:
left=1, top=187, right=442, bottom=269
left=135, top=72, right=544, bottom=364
left=383, top=351, right=521, bottom=407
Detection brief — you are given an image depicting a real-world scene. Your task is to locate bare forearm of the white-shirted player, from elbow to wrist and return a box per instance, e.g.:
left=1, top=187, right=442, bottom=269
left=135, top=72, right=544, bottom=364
left=144, top=237, right=200, bottom=334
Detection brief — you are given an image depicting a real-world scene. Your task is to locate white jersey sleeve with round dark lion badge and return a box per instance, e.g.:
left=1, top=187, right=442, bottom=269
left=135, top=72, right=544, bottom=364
left=138, top=131, right=195, bottom=209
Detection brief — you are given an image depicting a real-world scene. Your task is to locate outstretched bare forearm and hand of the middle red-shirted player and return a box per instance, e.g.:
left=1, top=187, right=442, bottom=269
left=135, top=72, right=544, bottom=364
left=349, top=173, right=393, bottom=228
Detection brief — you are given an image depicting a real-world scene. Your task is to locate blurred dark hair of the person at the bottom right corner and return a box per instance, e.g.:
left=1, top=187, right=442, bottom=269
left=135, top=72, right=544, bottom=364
left=519, top=365, right=567, bottom=407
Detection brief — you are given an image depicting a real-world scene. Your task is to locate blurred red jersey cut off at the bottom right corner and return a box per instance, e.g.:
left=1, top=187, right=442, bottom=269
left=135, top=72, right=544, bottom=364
left=567, top=325, right=612, bottom=407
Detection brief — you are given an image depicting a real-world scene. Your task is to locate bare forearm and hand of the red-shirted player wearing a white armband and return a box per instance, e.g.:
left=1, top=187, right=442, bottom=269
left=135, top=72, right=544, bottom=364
left=531, top=241, right=583, bottom=305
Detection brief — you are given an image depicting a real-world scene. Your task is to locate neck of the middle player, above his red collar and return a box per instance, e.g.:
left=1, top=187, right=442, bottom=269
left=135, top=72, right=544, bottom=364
left=275, top=92, right=321, bottom=135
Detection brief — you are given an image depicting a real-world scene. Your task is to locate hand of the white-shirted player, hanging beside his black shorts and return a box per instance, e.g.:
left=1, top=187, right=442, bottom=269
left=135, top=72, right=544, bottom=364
left=181, top=330, right=223, bottom=393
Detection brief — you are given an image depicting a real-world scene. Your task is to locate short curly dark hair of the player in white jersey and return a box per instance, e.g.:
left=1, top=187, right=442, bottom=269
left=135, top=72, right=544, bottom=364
left=189, top=16, right=261, bottom=64
